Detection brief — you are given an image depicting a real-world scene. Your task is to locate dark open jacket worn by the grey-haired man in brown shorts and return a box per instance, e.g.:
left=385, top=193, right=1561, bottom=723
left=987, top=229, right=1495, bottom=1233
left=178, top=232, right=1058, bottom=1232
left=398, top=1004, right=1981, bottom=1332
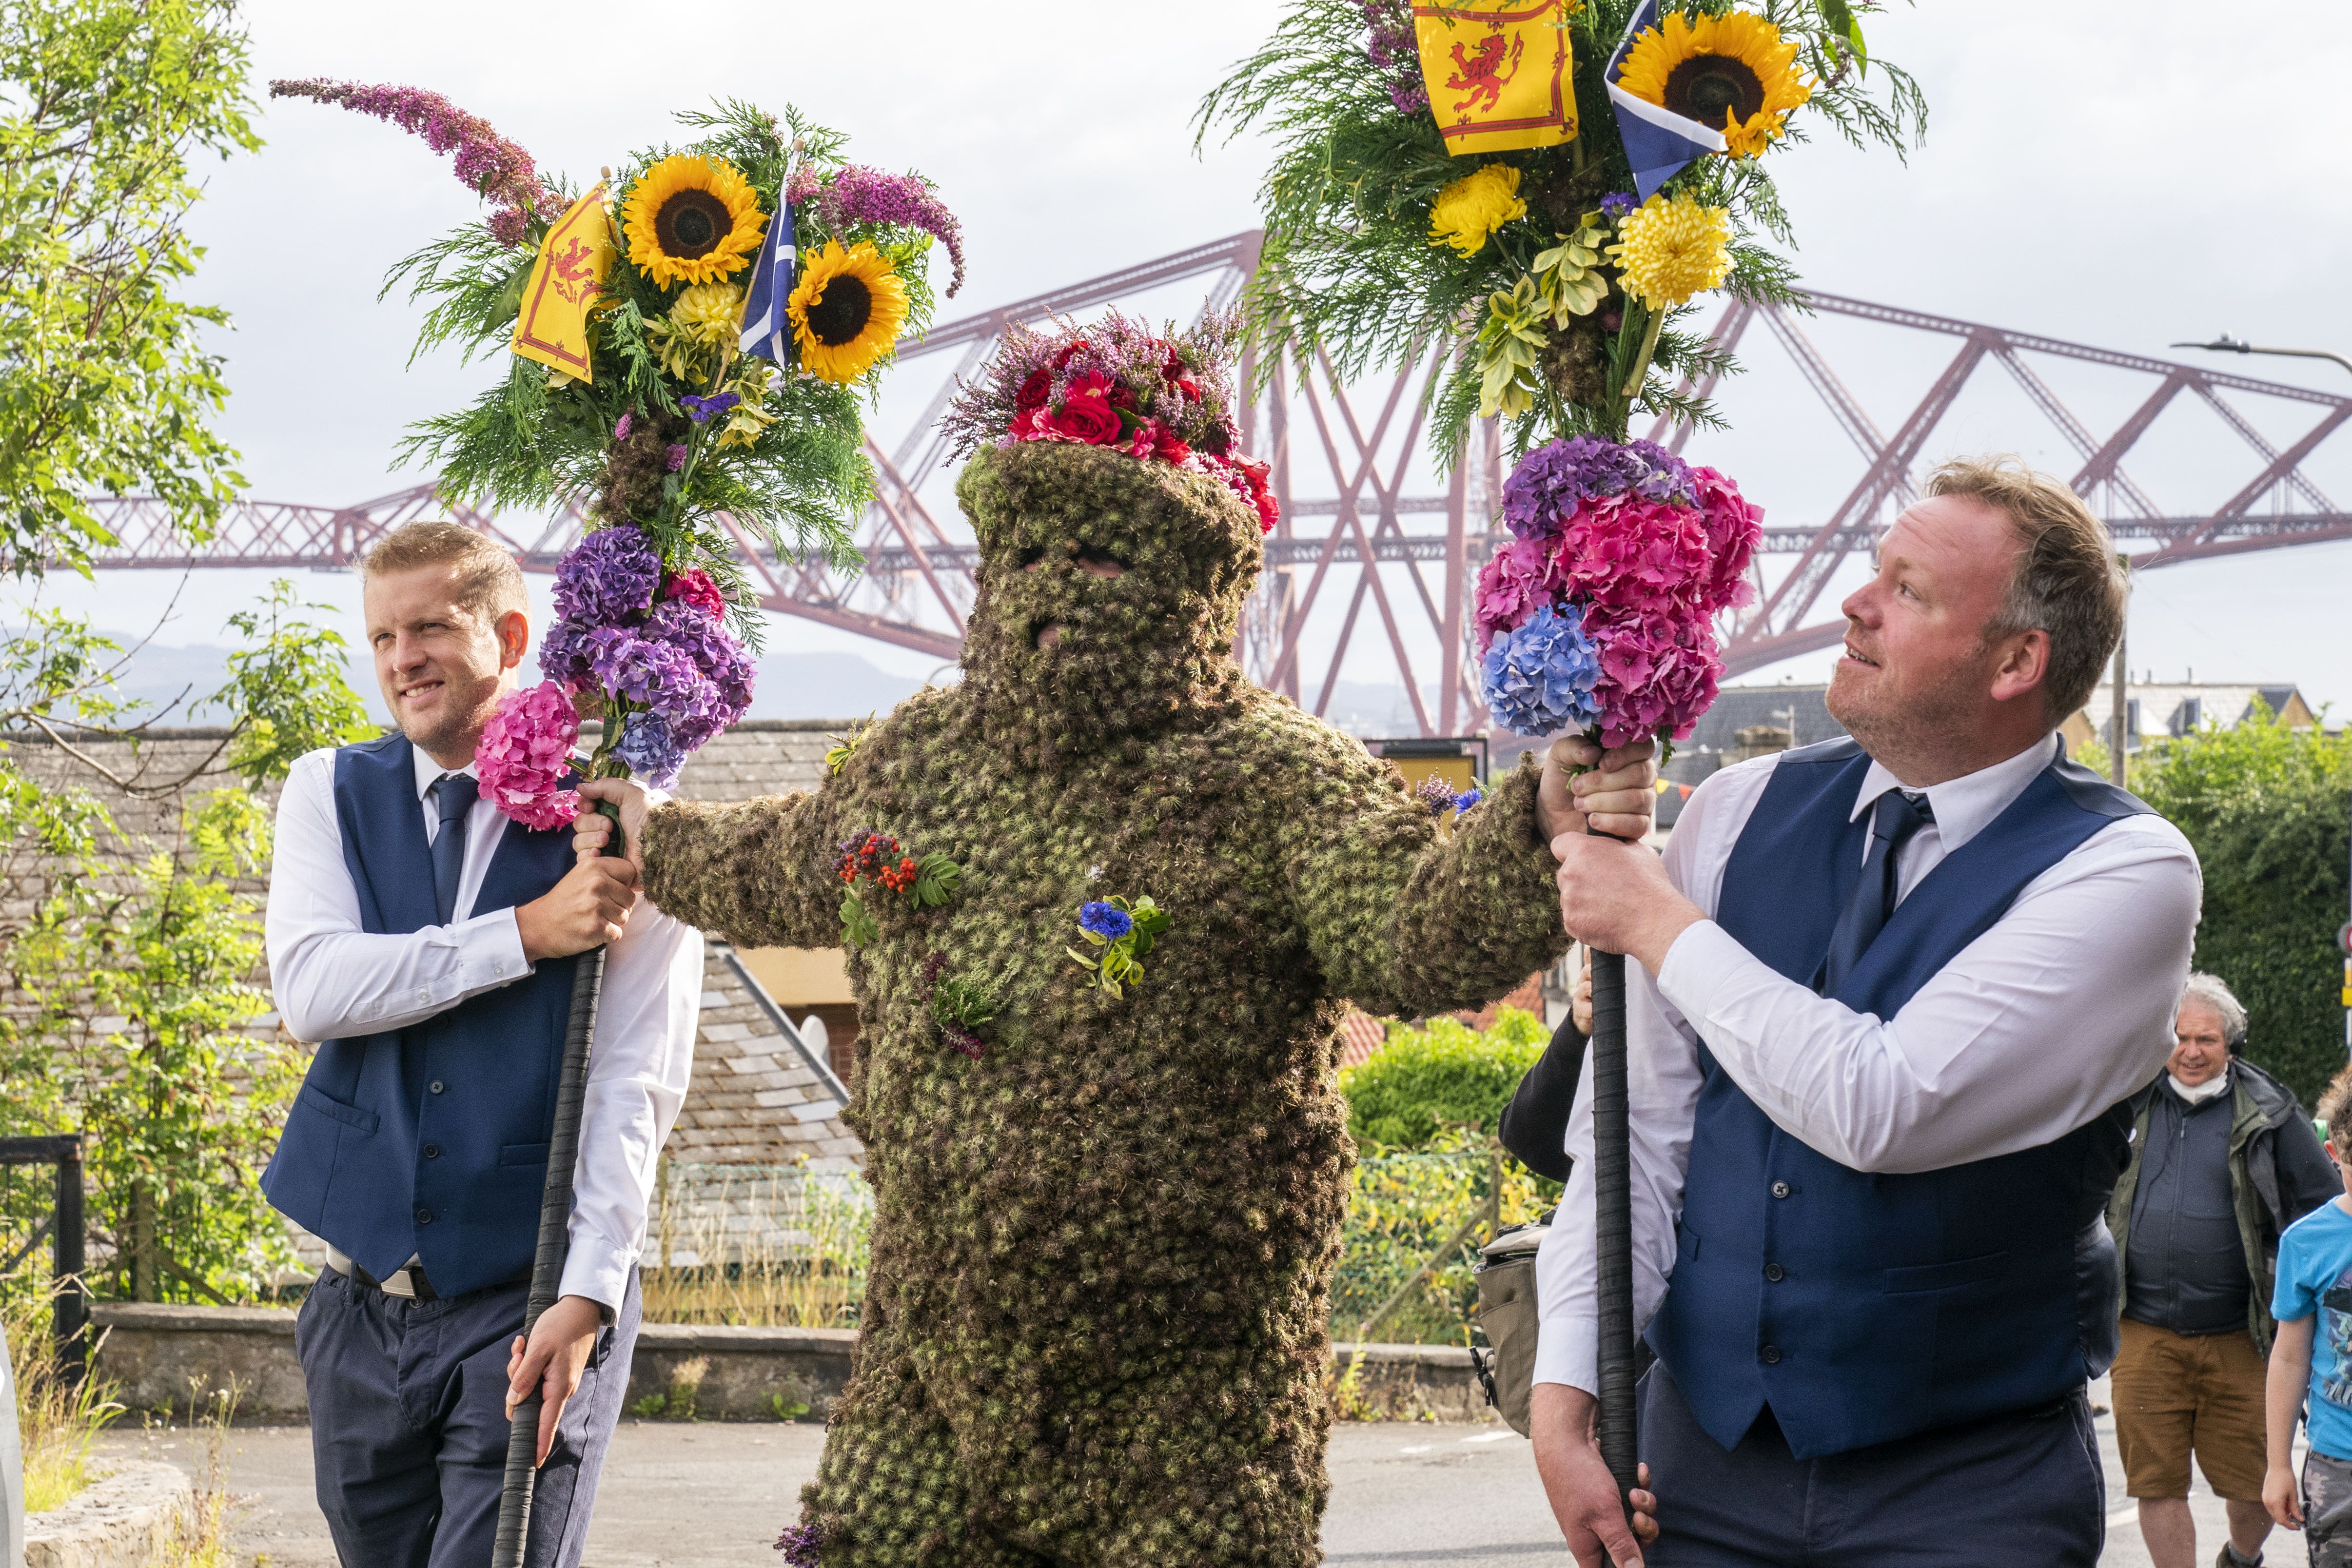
left=2107, top=1058, right=2343, bottom=1356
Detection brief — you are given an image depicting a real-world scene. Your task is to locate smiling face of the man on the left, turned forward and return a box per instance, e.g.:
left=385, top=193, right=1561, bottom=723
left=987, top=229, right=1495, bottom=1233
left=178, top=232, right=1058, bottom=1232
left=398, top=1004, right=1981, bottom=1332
left=362, top=564, right=529, bottom=769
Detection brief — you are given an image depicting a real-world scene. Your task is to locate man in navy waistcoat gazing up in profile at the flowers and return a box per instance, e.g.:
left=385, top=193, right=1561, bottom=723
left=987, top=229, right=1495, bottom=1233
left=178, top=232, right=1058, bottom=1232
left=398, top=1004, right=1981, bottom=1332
left=1533, top=458, right=2199, bottom=1568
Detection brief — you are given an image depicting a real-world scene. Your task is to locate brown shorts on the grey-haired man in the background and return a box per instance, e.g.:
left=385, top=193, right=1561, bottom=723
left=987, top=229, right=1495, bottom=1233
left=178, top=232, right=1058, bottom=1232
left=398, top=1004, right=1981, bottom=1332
left=2107, top=1316, right=2267, bottom=1502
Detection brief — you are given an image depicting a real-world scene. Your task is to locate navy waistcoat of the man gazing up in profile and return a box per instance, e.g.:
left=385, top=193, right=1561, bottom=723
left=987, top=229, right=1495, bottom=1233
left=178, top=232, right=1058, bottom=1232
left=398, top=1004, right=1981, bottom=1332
left=1649, top=741, right=2147, bottom=1460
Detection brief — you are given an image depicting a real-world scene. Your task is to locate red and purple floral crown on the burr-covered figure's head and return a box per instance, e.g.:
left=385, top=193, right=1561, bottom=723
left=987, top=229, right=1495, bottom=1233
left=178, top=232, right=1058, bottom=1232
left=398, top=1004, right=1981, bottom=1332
left=945, top=310, right=1279, bottom=534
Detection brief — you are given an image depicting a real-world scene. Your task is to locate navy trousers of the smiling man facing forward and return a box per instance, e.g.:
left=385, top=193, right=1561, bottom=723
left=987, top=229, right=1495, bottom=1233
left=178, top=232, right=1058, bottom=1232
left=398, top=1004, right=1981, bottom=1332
left=294, top=1270, right=640, bottom=1568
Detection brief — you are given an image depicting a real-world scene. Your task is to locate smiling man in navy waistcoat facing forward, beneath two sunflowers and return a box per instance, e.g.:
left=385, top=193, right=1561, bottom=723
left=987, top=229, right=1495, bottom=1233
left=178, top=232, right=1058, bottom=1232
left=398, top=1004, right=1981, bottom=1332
left=261, top=522, right=703, bottom=1568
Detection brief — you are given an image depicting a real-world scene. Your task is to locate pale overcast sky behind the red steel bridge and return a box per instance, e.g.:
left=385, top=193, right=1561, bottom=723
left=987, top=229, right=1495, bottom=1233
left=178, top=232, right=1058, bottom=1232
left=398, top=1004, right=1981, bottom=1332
left=7, top=0, right=2352, bottom=724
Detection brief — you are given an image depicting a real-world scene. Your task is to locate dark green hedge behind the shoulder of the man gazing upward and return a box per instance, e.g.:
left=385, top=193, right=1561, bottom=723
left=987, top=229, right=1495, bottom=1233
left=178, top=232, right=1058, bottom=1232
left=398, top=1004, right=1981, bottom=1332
left=2119, top=707, right=2352, bottom=1105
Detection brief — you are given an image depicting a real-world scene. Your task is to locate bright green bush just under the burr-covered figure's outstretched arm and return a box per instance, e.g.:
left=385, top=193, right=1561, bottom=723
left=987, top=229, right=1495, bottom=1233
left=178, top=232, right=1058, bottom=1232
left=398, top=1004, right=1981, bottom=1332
left=1338, top=1006, right=1552, bottom=1150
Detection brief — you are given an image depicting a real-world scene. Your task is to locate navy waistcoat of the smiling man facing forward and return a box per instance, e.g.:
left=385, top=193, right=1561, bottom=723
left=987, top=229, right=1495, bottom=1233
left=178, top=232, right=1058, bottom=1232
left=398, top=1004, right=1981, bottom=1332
left=261, top=736, right=576, bottom=1295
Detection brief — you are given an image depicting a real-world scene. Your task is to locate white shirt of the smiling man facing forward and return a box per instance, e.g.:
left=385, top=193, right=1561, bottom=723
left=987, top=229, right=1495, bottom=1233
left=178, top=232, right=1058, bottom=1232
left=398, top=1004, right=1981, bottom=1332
left=266, top=750, right=703, bottom=1310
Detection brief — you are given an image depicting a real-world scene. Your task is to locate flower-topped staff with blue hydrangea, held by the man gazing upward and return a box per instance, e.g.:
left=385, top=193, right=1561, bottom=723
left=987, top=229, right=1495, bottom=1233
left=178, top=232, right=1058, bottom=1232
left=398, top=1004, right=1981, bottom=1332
left=1199, top=0, right=1924, bottom=1523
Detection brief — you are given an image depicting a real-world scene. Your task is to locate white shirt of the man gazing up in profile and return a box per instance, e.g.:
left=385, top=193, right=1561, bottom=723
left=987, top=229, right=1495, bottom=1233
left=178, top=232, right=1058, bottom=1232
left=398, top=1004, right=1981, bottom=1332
left=1536, top=738, right=2201, bottom=1392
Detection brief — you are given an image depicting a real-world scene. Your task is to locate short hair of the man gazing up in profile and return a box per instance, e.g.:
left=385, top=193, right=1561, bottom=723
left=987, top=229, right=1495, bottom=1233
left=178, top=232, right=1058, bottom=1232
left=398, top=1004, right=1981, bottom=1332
left=1926, top=454, right=2124, bottom=724
